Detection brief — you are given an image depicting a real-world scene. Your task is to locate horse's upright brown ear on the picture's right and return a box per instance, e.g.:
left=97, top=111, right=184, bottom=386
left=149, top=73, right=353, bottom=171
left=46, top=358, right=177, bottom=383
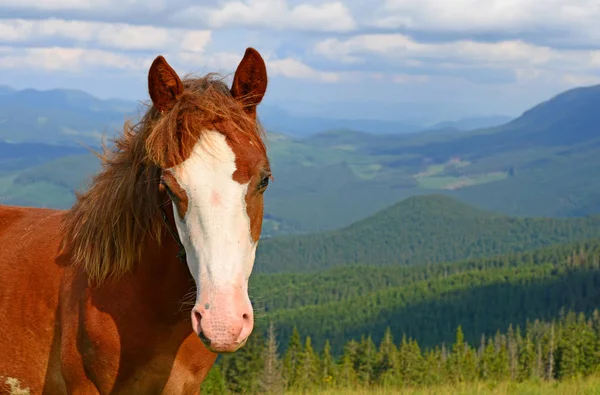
left=231, top=48, right=267, bottom=115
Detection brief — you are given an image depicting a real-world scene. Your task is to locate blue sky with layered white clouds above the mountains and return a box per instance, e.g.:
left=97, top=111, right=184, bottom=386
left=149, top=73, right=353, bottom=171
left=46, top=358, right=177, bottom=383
left=0, top=0, right=600, bottom=121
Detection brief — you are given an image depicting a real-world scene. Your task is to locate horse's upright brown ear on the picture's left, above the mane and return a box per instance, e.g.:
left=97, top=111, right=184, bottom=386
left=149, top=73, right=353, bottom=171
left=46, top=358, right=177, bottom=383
left=148, top=55, right=183, bottom=113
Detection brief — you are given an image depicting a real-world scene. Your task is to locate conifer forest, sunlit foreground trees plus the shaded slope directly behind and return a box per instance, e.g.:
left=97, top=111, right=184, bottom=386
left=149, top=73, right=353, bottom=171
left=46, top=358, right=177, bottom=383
left=193, top=239, right=600, bottom=394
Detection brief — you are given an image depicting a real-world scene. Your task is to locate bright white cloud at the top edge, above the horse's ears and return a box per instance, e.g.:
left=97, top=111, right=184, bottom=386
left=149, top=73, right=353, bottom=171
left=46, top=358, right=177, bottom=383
left=172, top=0, right=356, bottom=32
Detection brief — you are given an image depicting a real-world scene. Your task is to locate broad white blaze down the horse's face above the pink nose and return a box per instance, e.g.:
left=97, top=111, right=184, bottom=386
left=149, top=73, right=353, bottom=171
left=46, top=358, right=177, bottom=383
left=169, top=131, right=256, bottom=303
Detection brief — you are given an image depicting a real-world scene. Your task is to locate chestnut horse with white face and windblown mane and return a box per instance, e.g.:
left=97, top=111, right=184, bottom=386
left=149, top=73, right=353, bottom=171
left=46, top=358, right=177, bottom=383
left=0, top=47, right=272, bottom=394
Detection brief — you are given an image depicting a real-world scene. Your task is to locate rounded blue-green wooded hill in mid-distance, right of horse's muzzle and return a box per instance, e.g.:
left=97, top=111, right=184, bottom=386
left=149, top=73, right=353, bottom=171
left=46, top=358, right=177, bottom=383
left=255, top=195, right=600, bottom=272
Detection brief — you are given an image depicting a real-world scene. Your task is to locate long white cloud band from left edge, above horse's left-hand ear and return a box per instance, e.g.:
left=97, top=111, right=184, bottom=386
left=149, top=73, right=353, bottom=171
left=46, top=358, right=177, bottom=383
left=0, top=19, right=211, bottom=52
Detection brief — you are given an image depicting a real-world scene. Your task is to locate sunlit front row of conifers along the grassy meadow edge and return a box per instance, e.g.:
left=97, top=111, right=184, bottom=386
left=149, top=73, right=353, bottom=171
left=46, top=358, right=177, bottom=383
left=201, top=309, right=600, bottom=394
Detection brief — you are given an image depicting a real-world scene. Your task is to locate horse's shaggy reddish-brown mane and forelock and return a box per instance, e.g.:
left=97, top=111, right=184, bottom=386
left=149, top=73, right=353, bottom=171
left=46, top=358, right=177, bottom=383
left=61, top=73, right=266, bottom=283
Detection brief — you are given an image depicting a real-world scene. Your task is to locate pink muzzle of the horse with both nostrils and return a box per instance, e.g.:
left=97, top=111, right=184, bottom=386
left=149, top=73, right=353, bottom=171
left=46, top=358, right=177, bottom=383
left=192, top=298, right=254, bottom=353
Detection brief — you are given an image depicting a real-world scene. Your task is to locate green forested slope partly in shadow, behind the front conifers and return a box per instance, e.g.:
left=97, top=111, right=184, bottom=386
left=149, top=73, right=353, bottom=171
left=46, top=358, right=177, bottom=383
left=250, top=239, right=600, bottom=353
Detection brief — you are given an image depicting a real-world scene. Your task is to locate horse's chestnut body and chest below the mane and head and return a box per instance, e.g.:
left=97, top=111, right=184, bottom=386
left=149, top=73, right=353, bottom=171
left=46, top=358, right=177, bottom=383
left=0, top=206, right=216, bottom=394
